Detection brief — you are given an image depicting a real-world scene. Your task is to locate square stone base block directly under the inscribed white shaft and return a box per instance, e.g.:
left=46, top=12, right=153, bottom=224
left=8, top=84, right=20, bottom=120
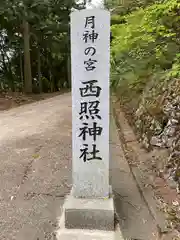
left=64, top=188, right=114, bottom=231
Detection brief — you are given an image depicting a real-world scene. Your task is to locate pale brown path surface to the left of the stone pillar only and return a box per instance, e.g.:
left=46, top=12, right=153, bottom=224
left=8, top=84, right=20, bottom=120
left=0, top=94, right=71, bottom=240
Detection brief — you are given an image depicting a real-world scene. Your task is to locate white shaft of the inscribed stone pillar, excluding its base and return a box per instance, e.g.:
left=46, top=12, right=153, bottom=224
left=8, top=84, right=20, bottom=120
left=71, top=9, right=110, bottom=198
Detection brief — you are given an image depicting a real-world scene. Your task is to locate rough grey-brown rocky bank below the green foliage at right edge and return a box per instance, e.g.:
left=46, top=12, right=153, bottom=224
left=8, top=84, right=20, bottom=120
left=135, top=79, right=180, bottom=192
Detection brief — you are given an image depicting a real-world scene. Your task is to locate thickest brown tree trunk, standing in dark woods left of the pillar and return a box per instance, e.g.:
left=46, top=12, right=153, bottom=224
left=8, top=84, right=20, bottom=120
left=23, top=20, right=32, bottom=93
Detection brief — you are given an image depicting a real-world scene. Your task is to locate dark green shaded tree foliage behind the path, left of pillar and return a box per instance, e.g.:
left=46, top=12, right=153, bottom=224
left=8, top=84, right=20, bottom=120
left=0, top=0, right=80, bottom=91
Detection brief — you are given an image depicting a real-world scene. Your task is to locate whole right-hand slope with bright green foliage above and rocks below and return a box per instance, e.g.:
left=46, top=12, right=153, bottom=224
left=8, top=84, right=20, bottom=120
left=111, top=0, right=180, bottom=234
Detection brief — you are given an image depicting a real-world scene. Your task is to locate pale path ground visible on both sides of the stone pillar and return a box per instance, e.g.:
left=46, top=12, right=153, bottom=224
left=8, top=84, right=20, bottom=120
left=0, top=94, right=156, bottom=240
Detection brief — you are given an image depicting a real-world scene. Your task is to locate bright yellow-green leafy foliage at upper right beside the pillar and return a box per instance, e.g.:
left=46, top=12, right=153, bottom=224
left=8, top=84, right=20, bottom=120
left=111, top=0, right=180, bottom=98
